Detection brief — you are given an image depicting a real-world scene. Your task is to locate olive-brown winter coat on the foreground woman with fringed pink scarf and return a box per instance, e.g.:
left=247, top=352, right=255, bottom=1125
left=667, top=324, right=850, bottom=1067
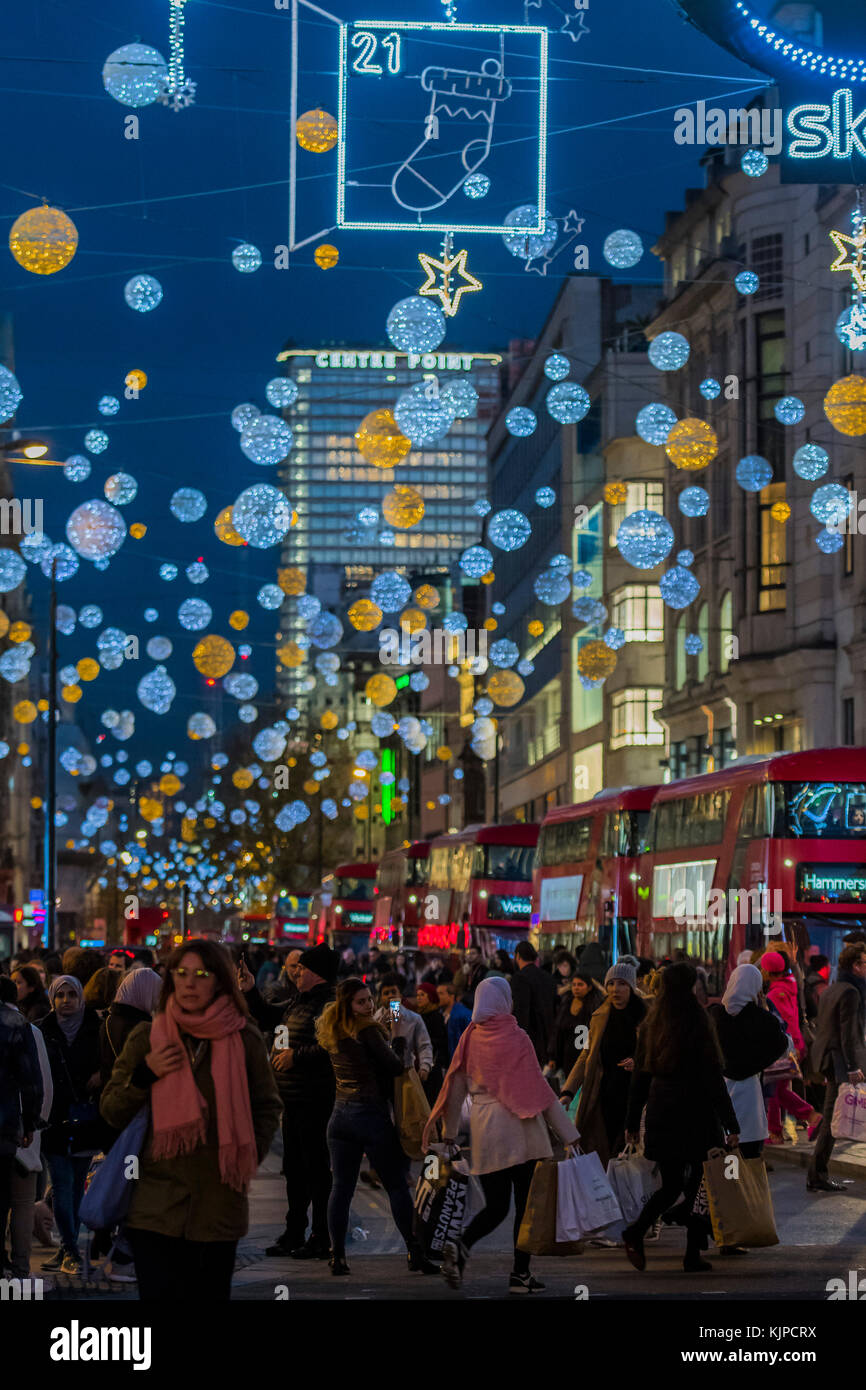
left=100, top=1022, right=281, bottom=1241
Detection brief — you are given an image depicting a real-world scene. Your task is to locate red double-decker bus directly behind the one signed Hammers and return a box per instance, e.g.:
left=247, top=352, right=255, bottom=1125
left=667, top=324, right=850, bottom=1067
left=531, top=787, right=657, bottom=970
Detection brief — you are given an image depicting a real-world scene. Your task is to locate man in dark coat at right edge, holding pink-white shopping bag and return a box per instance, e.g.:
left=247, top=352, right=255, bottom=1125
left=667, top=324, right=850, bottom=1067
left=806, top=941, right=866, bottom=1193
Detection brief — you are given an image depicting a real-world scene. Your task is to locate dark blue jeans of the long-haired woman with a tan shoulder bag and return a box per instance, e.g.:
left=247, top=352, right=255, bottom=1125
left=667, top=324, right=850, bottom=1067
left=328, top=1101, right=413, bottom=1258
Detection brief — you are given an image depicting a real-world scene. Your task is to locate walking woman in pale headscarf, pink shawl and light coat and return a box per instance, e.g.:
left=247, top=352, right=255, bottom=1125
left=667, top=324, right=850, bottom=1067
left=424, top=977, right=580, bottom=1294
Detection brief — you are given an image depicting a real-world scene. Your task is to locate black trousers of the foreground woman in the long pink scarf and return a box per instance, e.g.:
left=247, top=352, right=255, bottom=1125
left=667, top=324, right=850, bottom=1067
left=125, top=1226, right=238, bottom=1308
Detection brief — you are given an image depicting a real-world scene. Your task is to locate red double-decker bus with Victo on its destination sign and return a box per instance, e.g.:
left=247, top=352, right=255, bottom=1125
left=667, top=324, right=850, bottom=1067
left=418, top=823, right=538, bottom=958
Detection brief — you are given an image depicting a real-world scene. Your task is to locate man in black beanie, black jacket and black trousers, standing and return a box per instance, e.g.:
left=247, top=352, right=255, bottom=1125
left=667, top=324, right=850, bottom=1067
left=244, top=945, right=339, bottom=1259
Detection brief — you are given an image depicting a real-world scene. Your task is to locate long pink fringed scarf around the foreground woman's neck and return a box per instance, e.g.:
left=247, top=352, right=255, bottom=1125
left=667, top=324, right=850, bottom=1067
left=150, top=995, right=259, bottom=1193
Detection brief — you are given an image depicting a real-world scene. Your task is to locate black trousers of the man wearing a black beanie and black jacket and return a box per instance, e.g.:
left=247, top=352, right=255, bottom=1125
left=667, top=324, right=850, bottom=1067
left=282, top=1095, right=334, bottom=1250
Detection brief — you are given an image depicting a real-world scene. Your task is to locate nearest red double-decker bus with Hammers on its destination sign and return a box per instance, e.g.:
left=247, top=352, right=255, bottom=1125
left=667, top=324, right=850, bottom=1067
left=638, top=748, right=866, bottom=990
